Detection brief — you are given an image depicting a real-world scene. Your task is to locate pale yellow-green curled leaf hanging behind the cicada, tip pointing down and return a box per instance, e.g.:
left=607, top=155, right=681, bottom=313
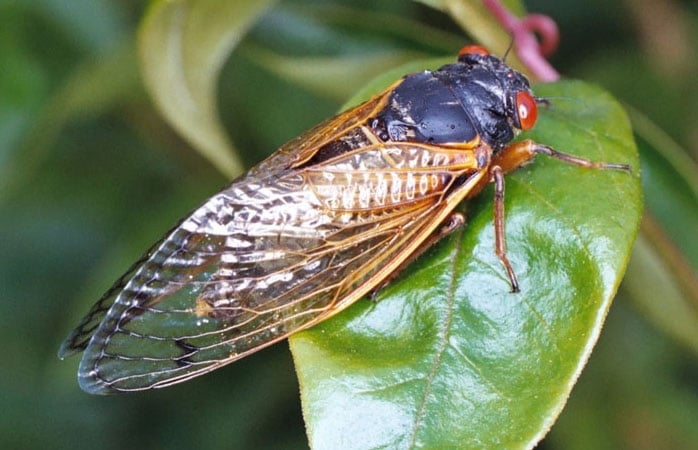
left=139, top=0, right=273, bottom=177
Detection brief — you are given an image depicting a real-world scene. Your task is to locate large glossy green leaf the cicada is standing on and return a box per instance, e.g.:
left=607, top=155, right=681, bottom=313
left=290, top=72, right=642, bottom=449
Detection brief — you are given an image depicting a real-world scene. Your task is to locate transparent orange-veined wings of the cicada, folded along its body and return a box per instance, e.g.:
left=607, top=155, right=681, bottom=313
left=61, top=95, right=482, bottom=393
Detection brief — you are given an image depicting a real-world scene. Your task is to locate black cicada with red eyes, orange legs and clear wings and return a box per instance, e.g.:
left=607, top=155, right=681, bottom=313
left=59, top=46, right=629, bottom=394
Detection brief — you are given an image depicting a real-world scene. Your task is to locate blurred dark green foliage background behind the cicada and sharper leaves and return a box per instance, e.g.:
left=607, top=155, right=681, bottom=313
left=0, top=0, right=698, bottom=449
